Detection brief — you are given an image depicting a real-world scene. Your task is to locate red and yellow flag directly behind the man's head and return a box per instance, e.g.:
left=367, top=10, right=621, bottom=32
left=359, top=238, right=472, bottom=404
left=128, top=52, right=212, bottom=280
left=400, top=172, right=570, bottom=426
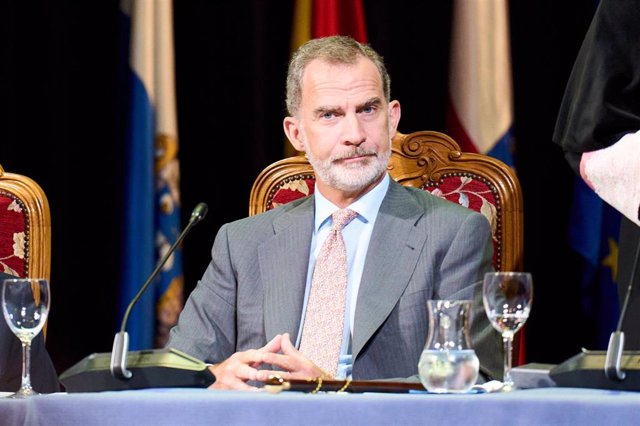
left=284, top=0, right=367, bottom=157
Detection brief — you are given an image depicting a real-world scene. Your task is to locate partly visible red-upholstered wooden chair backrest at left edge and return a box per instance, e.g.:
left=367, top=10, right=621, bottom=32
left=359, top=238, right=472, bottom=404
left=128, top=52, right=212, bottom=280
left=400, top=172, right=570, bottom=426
left=0, top=166, right=51, bottom=280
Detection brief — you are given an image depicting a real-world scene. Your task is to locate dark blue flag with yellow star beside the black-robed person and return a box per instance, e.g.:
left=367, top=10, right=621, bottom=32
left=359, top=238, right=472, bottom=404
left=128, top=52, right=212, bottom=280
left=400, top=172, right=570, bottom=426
left=569, top=177, right=620, bottom=349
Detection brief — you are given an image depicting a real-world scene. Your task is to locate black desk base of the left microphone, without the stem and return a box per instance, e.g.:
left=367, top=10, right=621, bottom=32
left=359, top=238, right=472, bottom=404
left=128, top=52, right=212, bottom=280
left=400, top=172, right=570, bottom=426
left=59, top=348, right=215, bottom=392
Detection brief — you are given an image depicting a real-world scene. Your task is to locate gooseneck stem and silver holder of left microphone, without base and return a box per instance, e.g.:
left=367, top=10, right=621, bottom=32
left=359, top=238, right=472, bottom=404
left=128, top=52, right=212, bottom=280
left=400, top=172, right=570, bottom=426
left=110, top=203, right=209, bottom=379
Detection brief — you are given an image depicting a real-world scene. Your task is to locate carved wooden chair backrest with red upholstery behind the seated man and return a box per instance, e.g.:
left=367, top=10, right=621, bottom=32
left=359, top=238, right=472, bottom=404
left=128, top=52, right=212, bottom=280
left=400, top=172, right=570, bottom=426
left=249, top=131, right=524, bottom=271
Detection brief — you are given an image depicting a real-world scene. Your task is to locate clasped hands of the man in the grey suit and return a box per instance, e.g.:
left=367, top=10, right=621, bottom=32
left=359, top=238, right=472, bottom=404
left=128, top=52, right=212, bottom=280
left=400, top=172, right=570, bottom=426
left=209, top=333, right=331, bottom=391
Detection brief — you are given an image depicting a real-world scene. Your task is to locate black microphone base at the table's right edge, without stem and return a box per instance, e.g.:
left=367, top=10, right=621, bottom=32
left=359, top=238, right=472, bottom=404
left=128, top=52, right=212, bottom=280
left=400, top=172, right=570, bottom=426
left=550, top=349, right=640, bottom=391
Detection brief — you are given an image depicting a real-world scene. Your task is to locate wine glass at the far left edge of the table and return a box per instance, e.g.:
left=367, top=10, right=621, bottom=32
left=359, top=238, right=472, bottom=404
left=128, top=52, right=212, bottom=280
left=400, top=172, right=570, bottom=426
left=2, top=278, right=50, bottom=398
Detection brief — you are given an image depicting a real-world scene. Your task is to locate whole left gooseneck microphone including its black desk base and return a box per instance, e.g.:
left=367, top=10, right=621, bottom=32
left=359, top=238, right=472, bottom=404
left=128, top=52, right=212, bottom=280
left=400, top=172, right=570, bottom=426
left=59, top=203, right=215, bottom=392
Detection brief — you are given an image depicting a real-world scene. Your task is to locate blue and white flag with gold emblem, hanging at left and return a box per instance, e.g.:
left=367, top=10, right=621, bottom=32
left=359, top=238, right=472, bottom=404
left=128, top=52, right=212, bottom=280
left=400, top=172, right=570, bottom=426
left=119, top=0, right=184, bottom=350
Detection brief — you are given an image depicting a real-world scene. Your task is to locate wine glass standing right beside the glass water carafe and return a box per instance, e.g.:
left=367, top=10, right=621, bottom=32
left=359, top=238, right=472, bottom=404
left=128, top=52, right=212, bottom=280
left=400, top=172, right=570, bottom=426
left=482, top=272, right=533, bottom=391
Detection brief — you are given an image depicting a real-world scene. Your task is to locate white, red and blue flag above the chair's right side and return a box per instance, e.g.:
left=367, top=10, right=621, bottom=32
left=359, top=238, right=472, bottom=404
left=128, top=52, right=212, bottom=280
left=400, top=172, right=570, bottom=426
left=447, top=0, right=513, bottom=166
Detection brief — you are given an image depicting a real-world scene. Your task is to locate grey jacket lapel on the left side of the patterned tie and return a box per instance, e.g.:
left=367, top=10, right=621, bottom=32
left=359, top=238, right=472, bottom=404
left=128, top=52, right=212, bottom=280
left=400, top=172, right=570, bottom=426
left=258, top=197, right=314, bottom=344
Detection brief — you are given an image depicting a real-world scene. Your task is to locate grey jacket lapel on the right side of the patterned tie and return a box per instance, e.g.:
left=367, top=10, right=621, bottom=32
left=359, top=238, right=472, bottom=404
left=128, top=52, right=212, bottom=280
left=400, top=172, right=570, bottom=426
left=352, top=181, right=427, bottom=360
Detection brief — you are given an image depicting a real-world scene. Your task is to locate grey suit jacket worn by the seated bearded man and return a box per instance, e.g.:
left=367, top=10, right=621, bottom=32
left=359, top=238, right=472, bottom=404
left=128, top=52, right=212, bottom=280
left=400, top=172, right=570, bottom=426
left=167, top=180, right=502, bottom=379
